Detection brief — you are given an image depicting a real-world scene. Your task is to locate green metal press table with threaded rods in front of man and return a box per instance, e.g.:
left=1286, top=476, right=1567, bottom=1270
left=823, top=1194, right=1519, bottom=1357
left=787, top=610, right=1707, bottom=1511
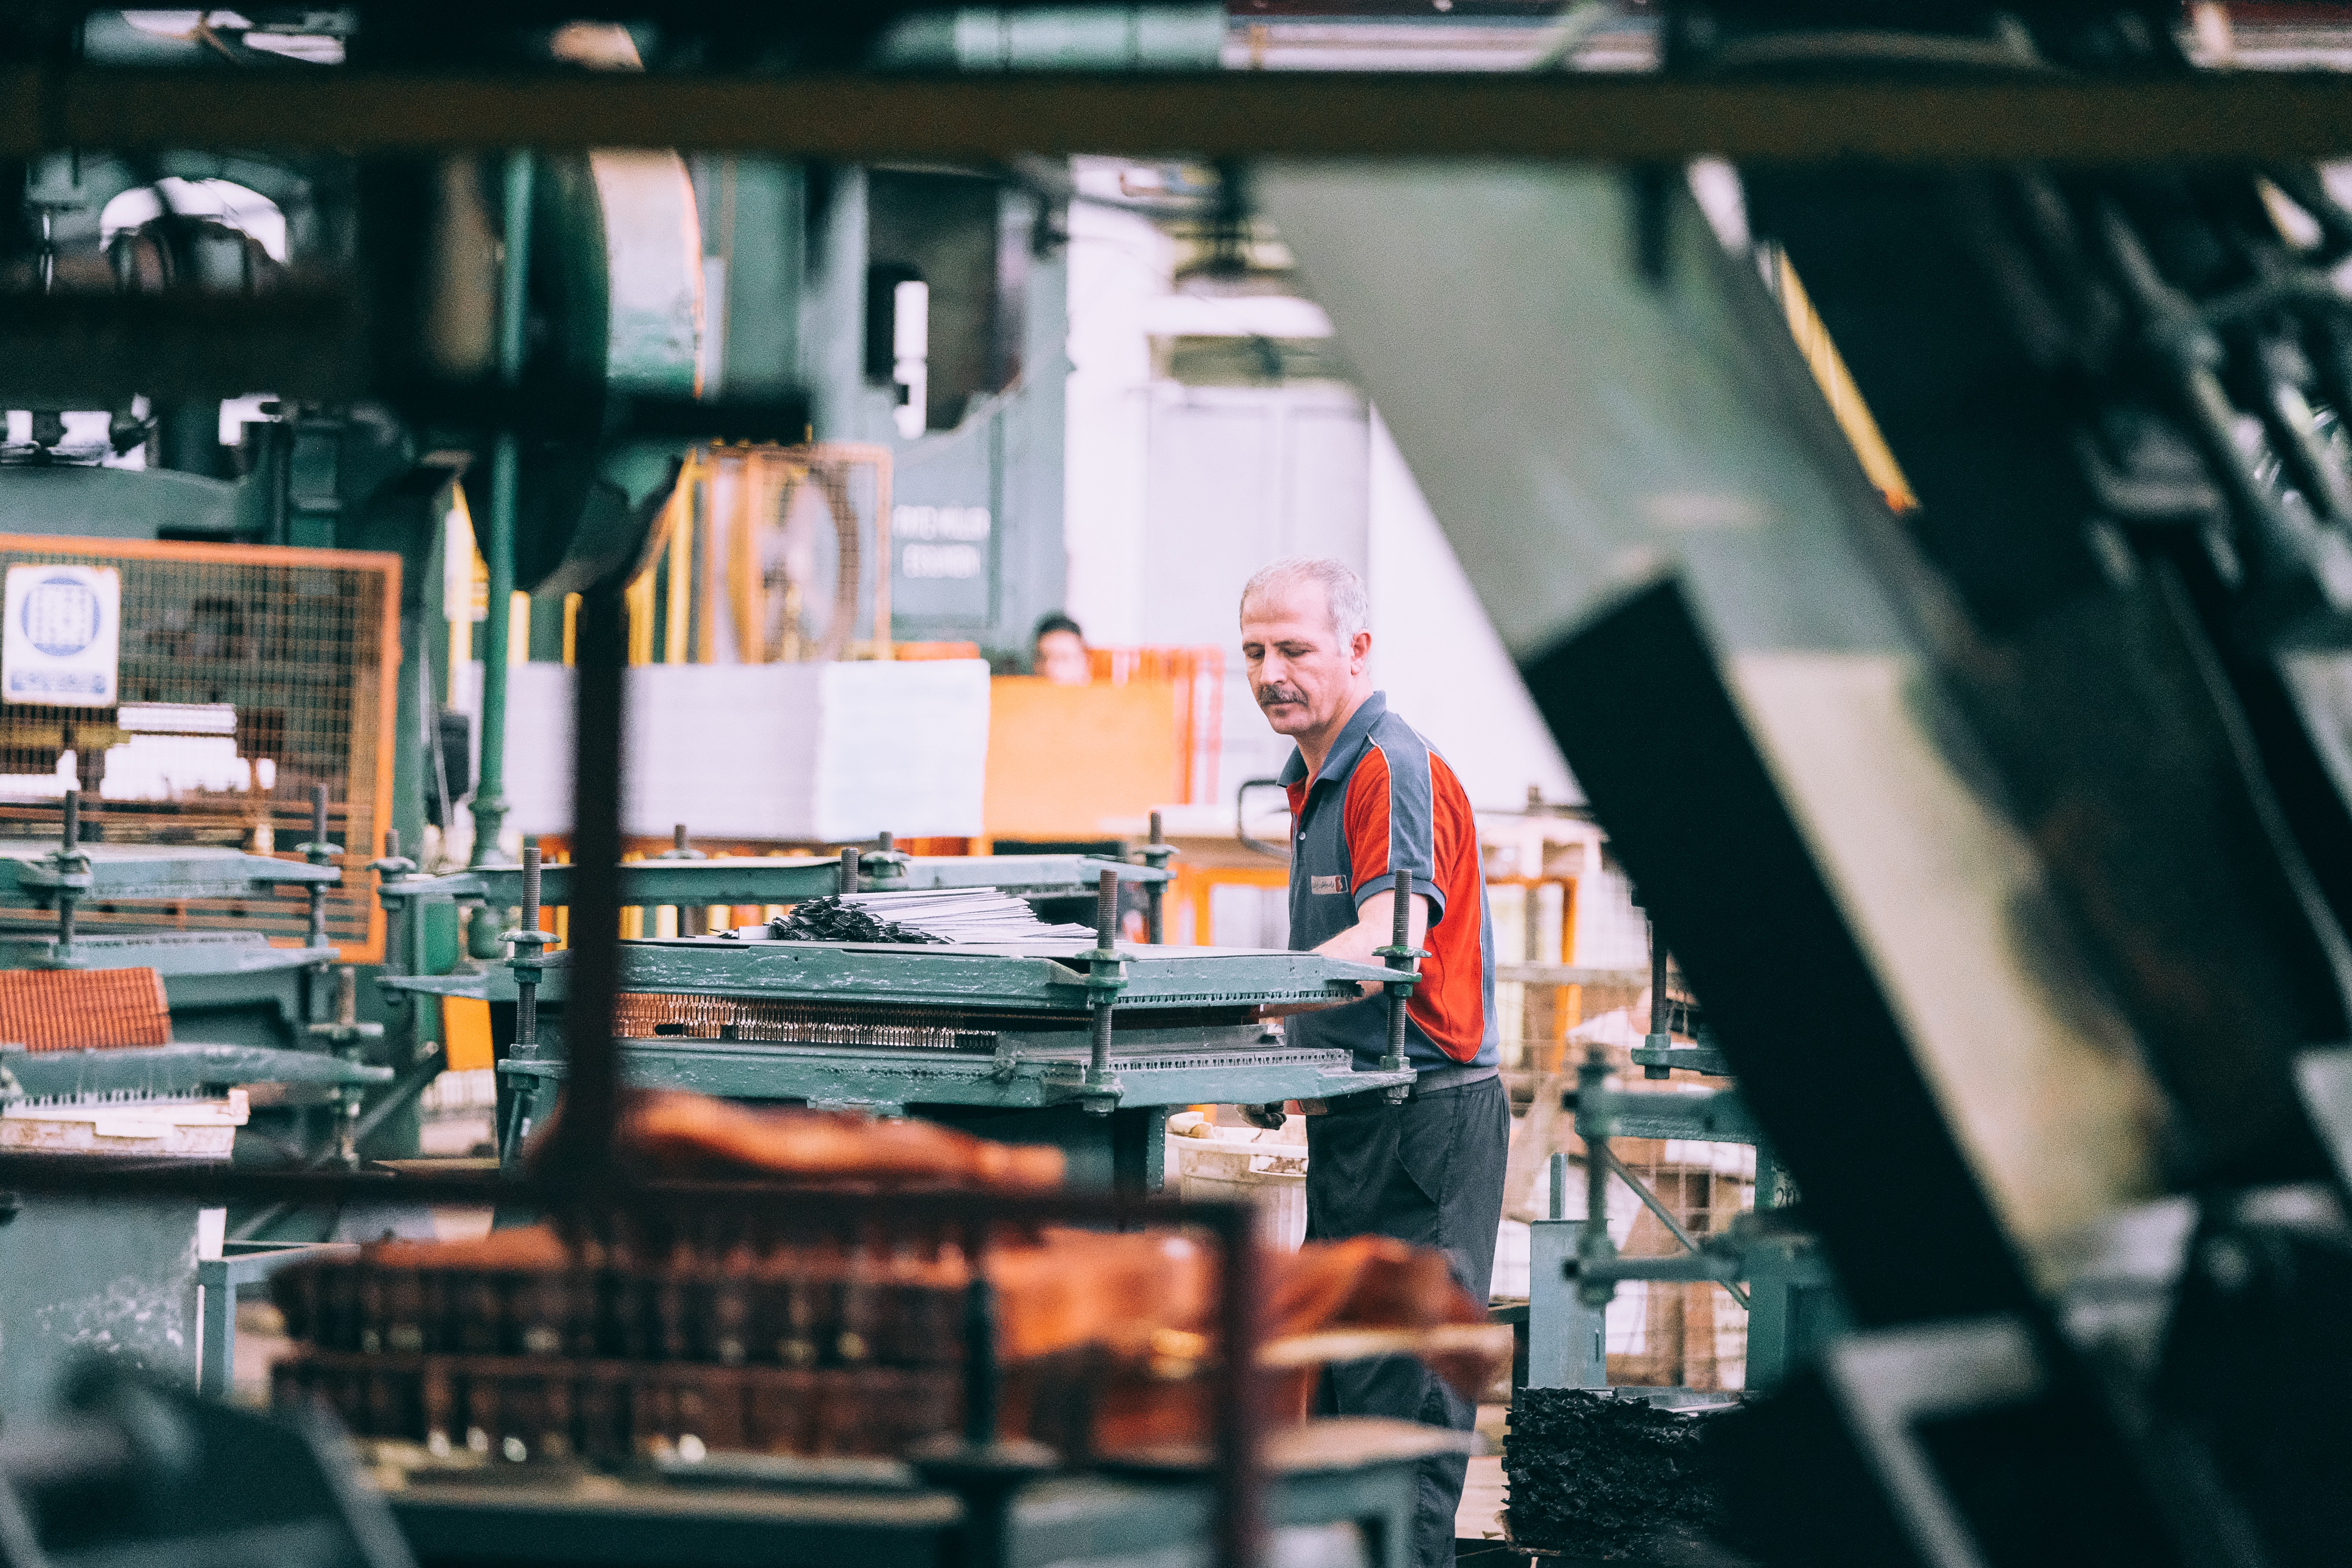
left=367, top=851, right=1409, bottom=1189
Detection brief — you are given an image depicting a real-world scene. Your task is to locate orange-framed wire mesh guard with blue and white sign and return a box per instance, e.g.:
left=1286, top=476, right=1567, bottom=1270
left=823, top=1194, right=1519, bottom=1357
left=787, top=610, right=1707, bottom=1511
left=0, top=536, right=400, bottom=964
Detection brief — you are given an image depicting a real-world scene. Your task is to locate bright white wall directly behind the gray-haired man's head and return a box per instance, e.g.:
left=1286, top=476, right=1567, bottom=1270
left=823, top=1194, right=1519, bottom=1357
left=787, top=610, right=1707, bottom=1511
left=1065, top=160, right=1578, bottom=811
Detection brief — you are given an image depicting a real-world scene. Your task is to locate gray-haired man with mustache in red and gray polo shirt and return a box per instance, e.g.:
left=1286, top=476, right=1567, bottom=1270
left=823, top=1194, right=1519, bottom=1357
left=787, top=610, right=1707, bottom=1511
left=1242, top=557, right=1510, bottom=1568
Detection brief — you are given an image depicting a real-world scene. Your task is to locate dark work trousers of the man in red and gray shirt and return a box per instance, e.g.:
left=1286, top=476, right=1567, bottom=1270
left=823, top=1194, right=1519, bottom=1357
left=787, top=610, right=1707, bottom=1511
left=1308, top=1077, right=1510, bottom=1568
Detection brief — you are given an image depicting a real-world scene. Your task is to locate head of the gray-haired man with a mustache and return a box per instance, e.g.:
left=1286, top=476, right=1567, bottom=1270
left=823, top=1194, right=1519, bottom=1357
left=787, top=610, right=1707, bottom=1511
left=1242, top=555, right=1371, bottom=740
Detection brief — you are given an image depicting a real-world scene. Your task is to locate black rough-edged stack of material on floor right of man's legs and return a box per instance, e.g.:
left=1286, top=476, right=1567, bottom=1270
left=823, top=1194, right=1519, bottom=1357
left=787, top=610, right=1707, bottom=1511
left=1503, top=1389, right=1745, bottom=1568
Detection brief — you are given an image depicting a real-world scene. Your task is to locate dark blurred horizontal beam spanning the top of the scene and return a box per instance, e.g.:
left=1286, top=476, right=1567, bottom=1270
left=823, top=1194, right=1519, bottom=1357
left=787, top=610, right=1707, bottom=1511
left=14, top=68, right=2352, bottom=165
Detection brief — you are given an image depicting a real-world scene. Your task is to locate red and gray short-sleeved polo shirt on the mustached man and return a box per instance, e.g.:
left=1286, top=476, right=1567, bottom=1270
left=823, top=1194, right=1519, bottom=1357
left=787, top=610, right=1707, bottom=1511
left=1282, top=691, right=1501, bottom=1072
